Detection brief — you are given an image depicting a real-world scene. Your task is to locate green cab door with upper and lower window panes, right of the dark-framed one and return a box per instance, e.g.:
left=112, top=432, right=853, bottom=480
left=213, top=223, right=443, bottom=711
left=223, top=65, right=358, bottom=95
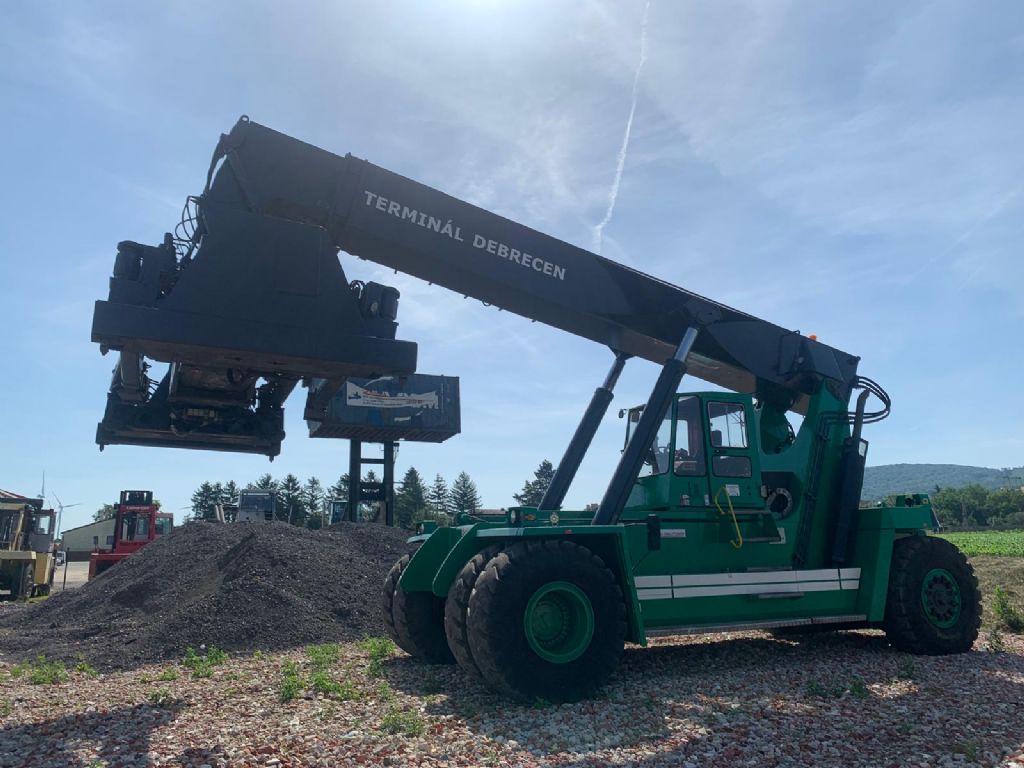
left=701, top=392, right=764, bottom=508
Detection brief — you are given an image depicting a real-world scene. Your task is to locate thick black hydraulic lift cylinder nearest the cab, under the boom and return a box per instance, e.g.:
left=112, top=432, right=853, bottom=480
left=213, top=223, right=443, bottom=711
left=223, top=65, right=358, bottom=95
left=592, top=327, right=697, bottom=525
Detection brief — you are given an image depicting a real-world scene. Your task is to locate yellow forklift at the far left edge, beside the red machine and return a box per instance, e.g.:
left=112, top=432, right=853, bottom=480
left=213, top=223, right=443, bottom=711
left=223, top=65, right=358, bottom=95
left=0, top=499, right=56, bottom=600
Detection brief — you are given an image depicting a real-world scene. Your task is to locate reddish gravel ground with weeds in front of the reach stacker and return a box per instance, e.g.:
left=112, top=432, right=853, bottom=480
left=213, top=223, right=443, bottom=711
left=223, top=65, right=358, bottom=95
left=0, top=632, right=1024, bottom=768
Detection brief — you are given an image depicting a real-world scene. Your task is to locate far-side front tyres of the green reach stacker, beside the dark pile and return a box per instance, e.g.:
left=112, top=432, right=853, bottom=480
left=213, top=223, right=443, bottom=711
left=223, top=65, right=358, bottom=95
left=383, top=555, right=455, bottom=664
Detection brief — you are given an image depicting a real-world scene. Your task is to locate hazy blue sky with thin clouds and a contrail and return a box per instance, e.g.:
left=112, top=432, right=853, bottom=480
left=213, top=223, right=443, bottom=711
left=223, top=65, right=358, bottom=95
left=0, top=0, right=1024, bottom=528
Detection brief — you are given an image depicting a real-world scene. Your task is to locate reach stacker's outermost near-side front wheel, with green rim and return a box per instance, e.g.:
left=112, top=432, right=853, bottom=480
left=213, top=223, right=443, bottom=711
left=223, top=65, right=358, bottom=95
left=467, top=540, right=626, bottom=702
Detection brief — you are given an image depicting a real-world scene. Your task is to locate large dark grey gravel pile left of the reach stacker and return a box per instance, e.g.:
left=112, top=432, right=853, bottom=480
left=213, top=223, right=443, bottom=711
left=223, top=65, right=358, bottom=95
left=0, top=522, right=408, bottom=670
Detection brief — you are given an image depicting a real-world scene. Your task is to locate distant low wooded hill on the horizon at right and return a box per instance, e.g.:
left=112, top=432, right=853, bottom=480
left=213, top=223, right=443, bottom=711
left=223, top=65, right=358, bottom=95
left=860, top=464, right=1024, bottom=502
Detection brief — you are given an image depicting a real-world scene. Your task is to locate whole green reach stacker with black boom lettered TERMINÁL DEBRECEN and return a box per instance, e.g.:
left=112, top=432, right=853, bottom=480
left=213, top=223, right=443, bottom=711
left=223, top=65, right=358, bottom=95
left=92, top=118, right=981, bottom=701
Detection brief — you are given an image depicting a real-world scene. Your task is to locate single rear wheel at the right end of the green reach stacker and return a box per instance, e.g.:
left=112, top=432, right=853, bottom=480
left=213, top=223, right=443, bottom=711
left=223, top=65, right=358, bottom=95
left=885, top=536, right=981, bottom=655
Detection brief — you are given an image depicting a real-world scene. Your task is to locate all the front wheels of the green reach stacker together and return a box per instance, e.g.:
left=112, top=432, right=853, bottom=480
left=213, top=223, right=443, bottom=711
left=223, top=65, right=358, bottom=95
left=384, top=541, right=626, bottom=701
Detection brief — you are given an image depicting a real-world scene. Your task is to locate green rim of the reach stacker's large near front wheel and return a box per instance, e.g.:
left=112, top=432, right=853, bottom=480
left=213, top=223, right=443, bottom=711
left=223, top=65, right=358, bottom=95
left=523, top=582, right=594, bottom=664
